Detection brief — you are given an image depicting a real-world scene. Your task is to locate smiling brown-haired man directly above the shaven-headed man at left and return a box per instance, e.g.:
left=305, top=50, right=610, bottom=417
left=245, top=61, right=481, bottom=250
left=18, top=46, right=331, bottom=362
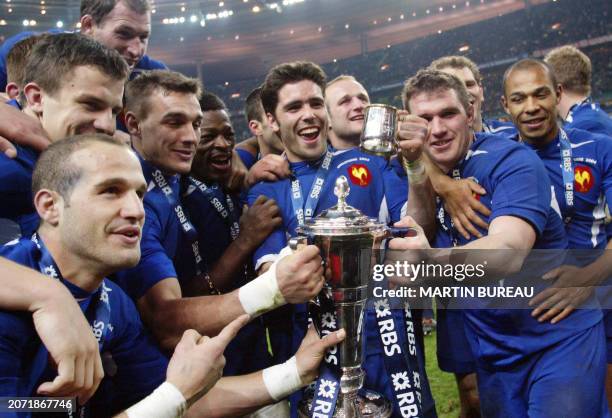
left=0, top=34, right=128, bottom=240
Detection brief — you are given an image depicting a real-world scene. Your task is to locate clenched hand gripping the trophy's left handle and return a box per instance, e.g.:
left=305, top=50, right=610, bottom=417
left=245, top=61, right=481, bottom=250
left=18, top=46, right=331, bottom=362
left=276, top=245, right=325, bottom=303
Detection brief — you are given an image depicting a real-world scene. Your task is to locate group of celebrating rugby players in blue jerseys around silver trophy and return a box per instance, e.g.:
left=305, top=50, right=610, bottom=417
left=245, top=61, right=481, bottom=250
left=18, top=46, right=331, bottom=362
left=0, top=0, right=612, bottom=418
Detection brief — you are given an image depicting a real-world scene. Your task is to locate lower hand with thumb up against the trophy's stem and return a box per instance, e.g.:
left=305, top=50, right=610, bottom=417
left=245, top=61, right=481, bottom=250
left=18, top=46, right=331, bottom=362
left=295, top=325, right=346, bottom=385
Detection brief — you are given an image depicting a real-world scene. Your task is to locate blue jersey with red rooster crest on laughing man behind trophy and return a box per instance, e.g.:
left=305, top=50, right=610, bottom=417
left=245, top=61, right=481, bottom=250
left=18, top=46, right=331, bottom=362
left=248, top=148, right=435, bottom=417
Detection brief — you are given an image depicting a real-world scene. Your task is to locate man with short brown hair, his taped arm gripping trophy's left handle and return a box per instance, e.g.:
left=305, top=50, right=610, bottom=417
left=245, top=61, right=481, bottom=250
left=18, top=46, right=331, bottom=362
left=115, top=70, right=323, bottom=372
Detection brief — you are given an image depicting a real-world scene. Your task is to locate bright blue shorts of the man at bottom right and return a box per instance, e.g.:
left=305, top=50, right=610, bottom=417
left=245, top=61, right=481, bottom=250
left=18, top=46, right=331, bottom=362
left=477, top=322, right=610, bottom=418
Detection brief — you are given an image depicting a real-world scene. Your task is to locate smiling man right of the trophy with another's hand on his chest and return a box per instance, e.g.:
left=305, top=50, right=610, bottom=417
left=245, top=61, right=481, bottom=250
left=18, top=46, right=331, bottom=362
left=391, top=70, right=606, bottom=418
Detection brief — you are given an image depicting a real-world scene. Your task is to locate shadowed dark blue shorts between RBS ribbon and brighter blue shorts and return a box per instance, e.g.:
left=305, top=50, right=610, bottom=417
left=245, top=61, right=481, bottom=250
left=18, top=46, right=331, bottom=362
left=436, top=309, right=476, bottom=374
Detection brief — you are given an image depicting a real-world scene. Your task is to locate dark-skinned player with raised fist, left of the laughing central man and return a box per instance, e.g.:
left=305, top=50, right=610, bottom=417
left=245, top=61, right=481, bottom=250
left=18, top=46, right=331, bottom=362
left=175, top=92, right=281, bottom=398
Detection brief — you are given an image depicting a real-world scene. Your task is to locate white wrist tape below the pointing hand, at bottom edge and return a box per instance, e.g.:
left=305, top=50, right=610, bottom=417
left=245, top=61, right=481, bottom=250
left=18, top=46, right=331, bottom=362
left=125, top=382, right=187, bottom=418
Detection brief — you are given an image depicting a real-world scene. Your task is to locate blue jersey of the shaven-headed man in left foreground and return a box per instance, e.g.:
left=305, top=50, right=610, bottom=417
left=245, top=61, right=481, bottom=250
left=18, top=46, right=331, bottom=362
left=0, top=239, right=168, bottom=417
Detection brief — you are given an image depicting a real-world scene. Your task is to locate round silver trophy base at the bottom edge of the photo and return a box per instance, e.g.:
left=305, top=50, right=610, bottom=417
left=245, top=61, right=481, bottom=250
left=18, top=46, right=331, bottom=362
left=298, top=390, right=393, bottom=418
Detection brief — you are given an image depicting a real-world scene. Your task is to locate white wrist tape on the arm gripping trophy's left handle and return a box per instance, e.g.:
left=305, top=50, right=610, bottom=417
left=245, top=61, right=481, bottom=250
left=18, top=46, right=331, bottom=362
left=238, top=247, right=292, bottom=317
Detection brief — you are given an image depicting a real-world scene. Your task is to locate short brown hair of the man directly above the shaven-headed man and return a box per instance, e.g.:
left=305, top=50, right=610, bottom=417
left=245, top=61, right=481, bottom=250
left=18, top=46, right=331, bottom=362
left=23, top=33, right=129, bottom=99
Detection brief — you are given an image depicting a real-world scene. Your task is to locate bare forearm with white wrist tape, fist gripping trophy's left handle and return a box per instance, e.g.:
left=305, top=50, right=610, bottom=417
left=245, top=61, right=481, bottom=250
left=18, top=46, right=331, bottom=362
left=137, top=245, right=324, bottom=350
